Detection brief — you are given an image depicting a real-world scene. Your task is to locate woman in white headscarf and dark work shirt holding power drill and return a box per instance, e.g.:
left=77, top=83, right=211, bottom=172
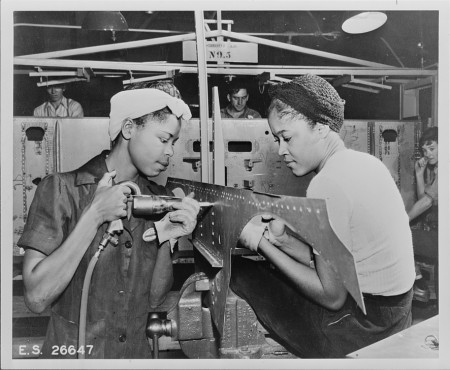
left=18, top=89, right=199, bottom=359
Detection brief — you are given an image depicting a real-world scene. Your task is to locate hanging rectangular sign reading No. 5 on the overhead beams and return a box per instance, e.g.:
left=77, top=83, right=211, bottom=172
left=183, top=41, right=258, bottom=63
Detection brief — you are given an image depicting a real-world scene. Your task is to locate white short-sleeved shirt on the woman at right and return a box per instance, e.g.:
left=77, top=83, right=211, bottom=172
left=307, top=149, right=415, bottom=296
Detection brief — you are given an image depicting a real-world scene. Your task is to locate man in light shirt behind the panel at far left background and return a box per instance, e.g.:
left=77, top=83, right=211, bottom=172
left=33, top=84, right=84, bottom=118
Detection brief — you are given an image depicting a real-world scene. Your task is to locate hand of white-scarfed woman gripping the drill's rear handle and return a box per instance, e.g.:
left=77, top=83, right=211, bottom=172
left=89, top=171, right=131, bottom=226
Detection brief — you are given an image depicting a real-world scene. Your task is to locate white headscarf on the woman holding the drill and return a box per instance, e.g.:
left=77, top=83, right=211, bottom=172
left=109, top=89, right=192, bottom=141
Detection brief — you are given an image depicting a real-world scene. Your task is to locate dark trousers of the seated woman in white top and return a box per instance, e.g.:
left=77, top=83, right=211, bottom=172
left=230, top=257, right=412, bottom=358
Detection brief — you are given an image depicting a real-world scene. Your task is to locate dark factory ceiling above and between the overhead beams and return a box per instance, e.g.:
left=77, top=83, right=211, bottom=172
left=14, top=10, right=439, bottom=73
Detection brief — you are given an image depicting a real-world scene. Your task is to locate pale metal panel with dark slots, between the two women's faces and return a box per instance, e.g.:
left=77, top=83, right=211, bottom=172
left=152, top=118, right=313, bottom=196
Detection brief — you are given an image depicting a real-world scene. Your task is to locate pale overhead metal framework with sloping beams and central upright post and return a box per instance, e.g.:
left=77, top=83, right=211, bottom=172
left=14, top=10, right=437, bottom=182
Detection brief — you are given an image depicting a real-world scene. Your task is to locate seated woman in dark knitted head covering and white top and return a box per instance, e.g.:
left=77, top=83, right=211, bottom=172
left=231, top=75, right=415, bottom=358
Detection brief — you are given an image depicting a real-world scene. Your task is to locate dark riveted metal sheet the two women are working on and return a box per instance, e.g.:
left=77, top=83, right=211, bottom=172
left=167, top=178, right=365, bottom=335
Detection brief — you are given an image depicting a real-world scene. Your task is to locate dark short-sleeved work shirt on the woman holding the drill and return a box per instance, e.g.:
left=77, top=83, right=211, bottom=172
left=18, top=151, right=173, bottom=359
